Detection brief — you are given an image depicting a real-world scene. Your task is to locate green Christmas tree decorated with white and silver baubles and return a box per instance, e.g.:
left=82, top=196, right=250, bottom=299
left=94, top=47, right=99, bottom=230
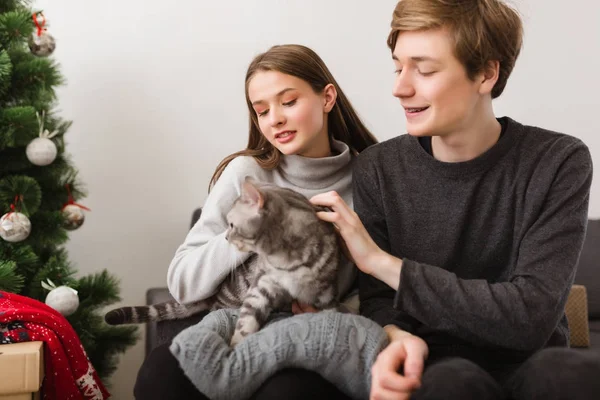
left=0, top=0, right=137, bottom=379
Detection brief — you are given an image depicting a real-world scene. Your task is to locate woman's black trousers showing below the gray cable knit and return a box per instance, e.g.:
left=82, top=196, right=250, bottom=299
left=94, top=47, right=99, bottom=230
left=133, top=345, right=349, bottom=400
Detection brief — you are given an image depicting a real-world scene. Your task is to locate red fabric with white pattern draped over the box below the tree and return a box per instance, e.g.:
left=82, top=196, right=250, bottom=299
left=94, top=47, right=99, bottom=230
left=0, top=291, right=110, bottom=400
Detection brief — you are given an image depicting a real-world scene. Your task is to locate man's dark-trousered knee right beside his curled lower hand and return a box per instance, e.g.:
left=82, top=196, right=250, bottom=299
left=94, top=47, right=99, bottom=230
left=411, top=358, right=504, bottom=400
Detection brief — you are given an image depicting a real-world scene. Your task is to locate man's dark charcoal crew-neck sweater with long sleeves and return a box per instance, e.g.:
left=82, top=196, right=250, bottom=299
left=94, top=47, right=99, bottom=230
left=353, top=118, right=592, bottom=363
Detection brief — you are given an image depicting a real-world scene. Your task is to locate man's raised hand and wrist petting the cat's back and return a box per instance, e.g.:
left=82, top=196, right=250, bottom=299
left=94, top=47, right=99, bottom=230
left=310, top=192, right=387, bottom=274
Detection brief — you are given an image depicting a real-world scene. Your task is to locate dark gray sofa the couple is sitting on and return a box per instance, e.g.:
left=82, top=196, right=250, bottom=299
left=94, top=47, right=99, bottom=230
left=145, top=209, right=600, bottom=355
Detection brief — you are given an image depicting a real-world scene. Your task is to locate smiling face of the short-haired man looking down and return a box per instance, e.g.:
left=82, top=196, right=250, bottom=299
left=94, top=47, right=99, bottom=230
left=393, top=29, right=491, bottom=136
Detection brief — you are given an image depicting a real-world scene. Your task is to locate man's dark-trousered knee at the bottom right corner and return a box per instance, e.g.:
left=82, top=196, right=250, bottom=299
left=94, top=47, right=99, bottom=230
left=508, top=347, right=600, bottom=400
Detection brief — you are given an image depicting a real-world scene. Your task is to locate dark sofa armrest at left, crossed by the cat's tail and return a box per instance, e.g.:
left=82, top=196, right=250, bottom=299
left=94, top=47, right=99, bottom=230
left=146, top=287, right=206, bottom=357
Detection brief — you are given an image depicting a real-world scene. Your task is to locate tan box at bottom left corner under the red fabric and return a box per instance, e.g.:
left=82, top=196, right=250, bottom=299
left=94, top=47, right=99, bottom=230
left=0, top=341, right=44, bottom=400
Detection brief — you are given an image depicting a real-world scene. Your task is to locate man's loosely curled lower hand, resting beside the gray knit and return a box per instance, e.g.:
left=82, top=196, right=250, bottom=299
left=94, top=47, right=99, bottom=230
left=369, top=326, right=429, bottom=400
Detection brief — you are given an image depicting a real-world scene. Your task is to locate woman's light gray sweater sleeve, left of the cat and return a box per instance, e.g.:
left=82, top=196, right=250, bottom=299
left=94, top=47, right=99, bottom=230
left=167, top=157, right=255, bottom=303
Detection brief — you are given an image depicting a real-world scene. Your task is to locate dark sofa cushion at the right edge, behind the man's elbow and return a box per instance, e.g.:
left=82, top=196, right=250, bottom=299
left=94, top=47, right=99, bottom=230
left=575, top=219, right=600, bottom=318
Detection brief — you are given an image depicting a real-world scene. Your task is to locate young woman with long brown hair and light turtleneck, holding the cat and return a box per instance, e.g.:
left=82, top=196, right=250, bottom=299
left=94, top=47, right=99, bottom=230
left=135, top=45, right=376, bottom=400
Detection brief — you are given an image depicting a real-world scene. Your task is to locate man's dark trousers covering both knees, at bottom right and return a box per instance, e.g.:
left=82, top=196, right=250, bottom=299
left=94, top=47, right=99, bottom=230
left=411, top=348, right=600, bottom=400
